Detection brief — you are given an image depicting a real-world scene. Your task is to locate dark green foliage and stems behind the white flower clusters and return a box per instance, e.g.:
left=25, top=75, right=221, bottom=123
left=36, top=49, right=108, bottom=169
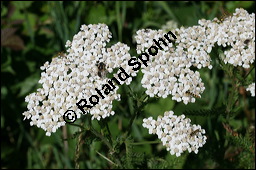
left=1, top=1, right=255, bottom=169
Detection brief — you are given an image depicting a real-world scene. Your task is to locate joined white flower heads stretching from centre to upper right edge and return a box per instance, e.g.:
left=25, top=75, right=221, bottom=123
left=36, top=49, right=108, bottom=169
left=135, top=9, right=255, bottom=104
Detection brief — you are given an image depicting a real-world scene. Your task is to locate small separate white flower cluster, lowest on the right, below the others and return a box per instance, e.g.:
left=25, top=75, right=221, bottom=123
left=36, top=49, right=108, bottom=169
left=142, top=111, right=206, bottom=157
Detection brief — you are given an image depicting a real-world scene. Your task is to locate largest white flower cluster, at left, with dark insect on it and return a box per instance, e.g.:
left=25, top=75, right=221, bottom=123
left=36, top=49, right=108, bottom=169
left=23, top=24, right=136, bottom=136
